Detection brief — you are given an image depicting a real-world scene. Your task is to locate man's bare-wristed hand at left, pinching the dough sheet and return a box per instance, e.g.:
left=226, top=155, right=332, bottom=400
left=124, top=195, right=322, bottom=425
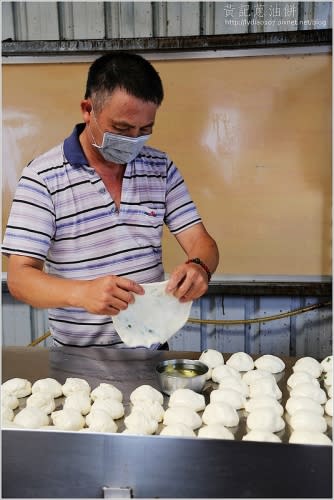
left=76, top=276, right=145, bottom=316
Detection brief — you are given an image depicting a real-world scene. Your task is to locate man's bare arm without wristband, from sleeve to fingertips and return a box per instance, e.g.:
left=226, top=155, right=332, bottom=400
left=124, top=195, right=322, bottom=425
left=7, top=255, right=144, bottom=315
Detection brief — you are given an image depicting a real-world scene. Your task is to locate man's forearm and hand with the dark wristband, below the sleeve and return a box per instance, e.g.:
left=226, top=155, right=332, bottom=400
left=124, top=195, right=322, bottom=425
left=167, top=223, right=219, bottom=302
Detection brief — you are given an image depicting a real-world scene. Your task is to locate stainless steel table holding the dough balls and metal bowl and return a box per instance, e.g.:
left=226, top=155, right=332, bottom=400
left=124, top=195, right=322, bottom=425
left=2, top=347, right=332, bottom=498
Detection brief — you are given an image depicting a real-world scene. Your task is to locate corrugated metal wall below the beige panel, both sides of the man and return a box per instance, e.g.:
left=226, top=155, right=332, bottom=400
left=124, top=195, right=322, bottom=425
left=2, top=286, right=332, bottom=359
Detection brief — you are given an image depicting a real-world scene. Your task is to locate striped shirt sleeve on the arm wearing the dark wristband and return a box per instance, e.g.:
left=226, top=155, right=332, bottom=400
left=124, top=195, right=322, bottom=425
left=165, top=160, right=202, bottom=234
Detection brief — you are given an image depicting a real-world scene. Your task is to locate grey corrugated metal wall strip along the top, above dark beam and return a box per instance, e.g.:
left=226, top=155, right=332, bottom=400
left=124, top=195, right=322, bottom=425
left=2, top=1, right=332, bottom=41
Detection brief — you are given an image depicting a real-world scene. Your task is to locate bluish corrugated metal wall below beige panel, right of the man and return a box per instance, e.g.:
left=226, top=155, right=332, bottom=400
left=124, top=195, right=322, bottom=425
left=170, top=295, right=332, bottom=358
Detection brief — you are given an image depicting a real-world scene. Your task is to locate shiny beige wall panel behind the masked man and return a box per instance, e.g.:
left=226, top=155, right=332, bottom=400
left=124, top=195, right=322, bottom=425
left=2, top=55, right=332, bottom=275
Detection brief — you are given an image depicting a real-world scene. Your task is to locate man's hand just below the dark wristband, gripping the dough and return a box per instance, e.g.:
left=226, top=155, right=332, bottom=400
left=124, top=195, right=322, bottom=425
left=166, top=262, right=208, bottom=302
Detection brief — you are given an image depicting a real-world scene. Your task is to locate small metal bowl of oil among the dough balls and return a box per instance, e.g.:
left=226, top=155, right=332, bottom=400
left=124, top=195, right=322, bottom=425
left=156, top=359, right=208, bottom=395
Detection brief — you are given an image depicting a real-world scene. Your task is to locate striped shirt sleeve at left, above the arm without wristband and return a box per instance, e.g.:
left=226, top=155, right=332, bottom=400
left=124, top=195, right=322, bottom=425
left=2, top=166, right=55, bottom=261
